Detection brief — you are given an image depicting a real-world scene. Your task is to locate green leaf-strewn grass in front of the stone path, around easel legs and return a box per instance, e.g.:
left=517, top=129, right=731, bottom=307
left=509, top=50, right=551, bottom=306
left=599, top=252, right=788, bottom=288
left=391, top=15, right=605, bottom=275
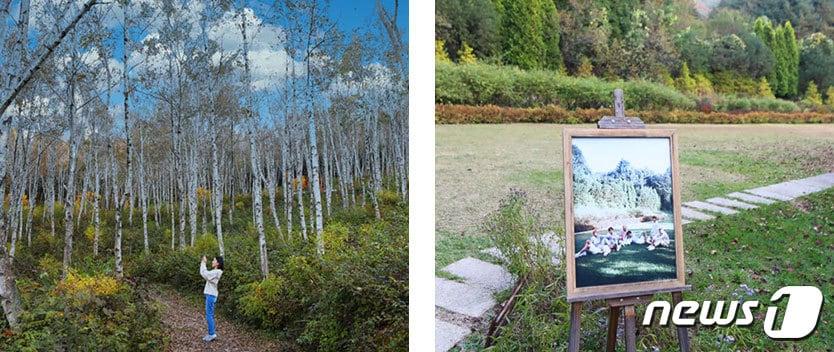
left=464, top=189, right=834, bottom=351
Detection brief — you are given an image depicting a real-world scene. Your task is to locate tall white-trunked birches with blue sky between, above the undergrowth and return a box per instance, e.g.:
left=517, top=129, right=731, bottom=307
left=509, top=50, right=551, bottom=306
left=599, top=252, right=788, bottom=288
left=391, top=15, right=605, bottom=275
left=0, top=0, right=408, bottom=328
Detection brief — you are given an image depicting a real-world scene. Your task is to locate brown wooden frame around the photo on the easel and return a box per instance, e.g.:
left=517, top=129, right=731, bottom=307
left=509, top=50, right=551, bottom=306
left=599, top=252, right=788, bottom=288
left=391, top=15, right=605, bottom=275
left=563, top=128, right=688, bottom=302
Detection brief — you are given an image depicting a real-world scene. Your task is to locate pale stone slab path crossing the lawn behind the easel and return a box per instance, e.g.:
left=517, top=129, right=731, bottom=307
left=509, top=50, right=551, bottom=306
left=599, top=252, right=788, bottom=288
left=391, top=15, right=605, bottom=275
left=434, top=172, right=834, bottom=352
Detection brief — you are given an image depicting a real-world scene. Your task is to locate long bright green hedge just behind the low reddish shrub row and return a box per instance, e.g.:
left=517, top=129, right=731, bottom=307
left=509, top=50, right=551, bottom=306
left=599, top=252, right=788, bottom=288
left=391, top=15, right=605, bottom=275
left=435, top=62, right=696, bottom=110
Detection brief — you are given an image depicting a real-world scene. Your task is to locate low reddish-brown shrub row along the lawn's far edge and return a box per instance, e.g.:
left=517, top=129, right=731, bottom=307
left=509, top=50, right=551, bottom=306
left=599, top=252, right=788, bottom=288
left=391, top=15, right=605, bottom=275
left=435, top=104, right=834, bottom=124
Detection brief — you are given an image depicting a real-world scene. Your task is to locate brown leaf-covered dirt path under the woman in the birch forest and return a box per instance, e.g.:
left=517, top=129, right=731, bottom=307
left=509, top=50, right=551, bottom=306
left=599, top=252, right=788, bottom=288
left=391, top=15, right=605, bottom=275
left=155, top=287, right=294, bottom=352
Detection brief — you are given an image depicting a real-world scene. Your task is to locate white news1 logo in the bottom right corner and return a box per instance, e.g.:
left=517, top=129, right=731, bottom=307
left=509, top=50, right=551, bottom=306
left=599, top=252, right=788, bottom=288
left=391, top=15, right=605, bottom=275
left=643, top=286, right=822, bottom=339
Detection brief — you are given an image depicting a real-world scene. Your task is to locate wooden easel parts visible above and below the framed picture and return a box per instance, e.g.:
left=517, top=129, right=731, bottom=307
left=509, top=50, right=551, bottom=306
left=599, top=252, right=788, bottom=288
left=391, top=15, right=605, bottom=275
left=568, top=89, right=689, bottom=352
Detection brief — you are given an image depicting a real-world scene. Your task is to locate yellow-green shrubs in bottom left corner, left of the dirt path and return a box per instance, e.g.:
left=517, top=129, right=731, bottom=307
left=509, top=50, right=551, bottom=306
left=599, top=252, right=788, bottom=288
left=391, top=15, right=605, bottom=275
left=0, top=272, right=168, bottom=351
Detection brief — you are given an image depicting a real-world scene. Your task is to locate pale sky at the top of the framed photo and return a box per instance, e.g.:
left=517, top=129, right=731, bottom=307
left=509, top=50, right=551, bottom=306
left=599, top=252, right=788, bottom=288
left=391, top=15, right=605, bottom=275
left=572, top=137, right=671, bottom=173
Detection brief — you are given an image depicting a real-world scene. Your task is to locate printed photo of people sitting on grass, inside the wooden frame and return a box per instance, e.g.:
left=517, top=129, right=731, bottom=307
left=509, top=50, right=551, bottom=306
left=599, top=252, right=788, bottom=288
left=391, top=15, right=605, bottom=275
left=571, top=137, right=676, bottom=287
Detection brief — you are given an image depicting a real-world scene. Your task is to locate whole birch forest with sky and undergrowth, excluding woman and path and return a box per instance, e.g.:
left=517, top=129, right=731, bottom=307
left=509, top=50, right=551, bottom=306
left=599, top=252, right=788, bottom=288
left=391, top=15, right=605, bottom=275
left=0, top=0, right=409, bottom=351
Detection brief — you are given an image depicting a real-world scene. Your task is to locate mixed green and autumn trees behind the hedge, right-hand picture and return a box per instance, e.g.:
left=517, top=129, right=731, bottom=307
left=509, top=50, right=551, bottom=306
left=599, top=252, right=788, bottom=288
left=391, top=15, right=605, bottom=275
left=435, top=0, right=834, bottom=99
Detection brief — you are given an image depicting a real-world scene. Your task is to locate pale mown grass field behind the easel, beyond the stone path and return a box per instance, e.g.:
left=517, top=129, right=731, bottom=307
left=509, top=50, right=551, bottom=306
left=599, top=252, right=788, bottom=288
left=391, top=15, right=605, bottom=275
left=435, top=124, right=834, bottom=268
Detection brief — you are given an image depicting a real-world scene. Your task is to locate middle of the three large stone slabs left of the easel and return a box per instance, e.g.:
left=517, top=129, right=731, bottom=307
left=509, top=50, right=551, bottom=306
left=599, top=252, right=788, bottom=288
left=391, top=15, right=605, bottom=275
left=434, top=277, right=497, bottom=318
